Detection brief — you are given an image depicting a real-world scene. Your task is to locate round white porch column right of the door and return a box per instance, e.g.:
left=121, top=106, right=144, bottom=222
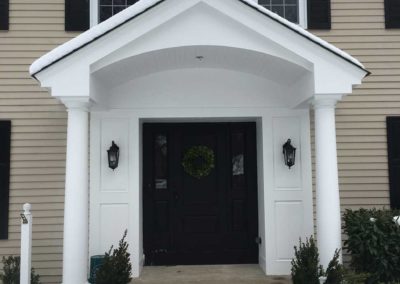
left=313, top=95, right=342, bottom=269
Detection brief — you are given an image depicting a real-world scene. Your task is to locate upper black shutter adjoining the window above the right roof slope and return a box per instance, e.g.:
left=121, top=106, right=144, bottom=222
left=307, top=0, right=332, bottom=30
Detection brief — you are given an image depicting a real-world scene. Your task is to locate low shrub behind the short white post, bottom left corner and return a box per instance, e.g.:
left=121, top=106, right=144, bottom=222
left=0, top=256, right=40, bottom=284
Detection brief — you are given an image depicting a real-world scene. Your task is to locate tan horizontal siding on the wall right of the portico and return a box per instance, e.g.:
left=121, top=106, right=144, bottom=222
left=314, top=0, right=400, bottom=212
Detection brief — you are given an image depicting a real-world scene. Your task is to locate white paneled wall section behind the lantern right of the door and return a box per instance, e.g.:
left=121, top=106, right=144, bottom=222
left=264, top=112, right=313, bottom=275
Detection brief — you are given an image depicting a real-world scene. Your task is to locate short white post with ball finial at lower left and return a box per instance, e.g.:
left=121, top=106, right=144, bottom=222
left=19, top=203, right=32, bottom=284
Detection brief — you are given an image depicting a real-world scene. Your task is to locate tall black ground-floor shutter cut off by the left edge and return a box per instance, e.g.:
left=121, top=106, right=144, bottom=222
left=0, top=121, right=11, bottom=240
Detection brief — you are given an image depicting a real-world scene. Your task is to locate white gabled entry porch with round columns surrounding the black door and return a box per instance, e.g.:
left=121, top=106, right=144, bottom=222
left=31, top=0, right=368, bottom=284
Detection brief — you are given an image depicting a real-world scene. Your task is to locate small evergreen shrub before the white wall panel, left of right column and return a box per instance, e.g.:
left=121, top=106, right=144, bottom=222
left=292, top=237, right=322, bottom=284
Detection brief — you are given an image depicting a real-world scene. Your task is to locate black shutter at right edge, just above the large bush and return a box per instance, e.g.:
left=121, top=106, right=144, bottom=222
left=386, top=116, right=400, bottom=209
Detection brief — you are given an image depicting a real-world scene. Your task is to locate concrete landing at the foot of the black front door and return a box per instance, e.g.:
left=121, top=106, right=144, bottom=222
left=132, top=264, right=292, bottom=284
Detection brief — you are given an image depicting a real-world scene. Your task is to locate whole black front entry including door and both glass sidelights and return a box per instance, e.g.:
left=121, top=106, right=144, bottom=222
left=143, top=123, right=258, bottom=265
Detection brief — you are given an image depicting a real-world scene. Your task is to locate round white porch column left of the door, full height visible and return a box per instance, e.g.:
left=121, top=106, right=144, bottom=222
left=63, top=100, right=89, bottom=284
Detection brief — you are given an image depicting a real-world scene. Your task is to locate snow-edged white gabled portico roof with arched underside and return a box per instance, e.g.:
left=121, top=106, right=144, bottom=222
left=30, top=0, right=369, bottom=108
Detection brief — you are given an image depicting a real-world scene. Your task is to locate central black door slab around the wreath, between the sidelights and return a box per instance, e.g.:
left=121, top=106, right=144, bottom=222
left=172, top=125, right=226, bottom=259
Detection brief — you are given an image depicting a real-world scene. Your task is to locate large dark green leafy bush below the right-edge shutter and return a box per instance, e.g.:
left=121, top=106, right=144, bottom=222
left=344, top=209, right=400, bottom=283
